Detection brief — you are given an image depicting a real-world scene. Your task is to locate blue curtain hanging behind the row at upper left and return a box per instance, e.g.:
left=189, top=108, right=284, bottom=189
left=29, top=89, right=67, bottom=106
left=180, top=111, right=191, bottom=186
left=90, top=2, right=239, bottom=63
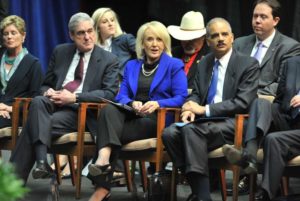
left=10, top=0, right=80, bottom=71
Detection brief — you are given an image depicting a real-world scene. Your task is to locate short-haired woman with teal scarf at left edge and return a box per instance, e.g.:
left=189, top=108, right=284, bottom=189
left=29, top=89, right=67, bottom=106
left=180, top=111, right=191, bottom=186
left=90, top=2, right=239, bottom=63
left=0, top=15, right=43, bottom=128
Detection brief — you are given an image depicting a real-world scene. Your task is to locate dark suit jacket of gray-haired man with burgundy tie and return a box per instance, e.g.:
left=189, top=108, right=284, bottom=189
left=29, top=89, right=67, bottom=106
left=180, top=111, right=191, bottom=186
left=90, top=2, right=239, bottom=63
left=41, top=44, right=119, bottom=135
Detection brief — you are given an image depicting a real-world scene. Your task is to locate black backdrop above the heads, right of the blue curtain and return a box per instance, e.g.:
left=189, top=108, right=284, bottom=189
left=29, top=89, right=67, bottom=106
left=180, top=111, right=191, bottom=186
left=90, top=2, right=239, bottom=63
left=82, top=0, right=300, bottom=45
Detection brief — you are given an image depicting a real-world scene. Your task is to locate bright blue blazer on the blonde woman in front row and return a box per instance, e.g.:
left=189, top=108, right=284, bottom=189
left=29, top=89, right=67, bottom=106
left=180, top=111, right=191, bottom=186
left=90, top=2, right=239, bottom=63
left=116, top=53, right=187, bottom=107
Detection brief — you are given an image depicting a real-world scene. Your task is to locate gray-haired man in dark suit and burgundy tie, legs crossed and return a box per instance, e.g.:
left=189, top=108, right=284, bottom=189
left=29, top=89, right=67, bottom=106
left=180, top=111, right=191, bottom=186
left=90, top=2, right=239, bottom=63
left=11, top=13, right=118, bottom=181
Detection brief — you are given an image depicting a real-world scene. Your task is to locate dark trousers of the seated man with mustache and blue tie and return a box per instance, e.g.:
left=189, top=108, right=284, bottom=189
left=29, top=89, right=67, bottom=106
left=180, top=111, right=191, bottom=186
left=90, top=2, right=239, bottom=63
left=162, top=118, right=235, bottom=176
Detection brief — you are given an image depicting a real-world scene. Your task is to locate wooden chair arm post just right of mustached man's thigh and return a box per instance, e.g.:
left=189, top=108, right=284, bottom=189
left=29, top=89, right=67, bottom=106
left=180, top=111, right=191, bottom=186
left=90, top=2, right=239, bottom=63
left=234, top=114, right=249, bottom=149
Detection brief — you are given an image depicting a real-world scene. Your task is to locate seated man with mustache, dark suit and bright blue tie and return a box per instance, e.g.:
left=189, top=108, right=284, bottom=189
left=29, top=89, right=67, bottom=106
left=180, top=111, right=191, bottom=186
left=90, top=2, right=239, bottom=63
left=162, top=18, right=259, bottom=201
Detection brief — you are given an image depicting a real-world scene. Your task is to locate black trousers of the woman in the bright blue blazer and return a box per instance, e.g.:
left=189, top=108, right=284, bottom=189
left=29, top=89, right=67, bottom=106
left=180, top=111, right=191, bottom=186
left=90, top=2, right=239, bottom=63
left=96, top=105, right=157, bottom=165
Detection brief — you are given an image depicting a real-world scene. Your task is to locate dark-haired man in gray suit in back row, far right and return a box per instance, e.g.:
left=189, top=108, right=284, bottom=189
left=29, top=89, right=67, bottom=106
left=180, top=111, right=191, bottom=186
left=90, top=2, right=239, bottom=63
left=233, top=0, right=300, bottom=96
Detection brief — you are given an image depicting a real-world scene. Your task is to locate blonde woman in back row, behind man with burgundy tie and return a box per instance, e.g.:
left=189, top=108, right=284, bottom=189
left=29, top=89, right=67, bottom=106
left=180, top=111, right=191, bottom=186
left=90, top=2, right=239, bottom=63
left=92, top=8, right=136, bottom=79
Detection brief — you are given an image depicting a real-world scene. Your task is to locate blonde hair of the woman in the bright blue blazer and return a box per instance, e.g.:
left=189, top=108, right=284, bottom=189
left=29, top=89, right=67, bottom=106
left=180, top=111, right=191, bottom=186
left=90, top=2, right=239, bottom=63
left=135, top=21, right=172, bottom=59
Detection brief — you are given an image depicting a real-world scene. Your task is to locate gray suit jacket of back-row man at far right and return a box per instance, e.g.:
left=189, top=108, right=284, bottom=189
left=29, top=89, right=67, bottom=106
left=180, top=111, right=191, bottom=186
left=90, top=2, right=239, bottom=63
left=234, top=30, right=300, bottom=96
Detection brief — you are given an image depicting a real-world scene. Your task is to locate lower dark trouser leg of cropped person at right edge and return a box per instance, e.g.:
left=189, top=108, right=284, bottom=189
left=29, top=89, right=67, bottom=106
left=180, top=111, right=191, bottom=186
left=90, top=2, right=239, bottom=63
left=261, top=130, right=300, bottom=199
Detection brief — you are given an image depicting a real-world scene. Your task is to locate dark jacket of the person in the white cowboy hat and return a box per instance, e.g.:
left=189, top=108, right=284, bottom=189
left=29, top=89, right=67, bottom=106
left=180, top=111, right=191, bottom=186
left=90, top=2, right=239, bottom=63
left=172, top=44, right=208, bottom=89
